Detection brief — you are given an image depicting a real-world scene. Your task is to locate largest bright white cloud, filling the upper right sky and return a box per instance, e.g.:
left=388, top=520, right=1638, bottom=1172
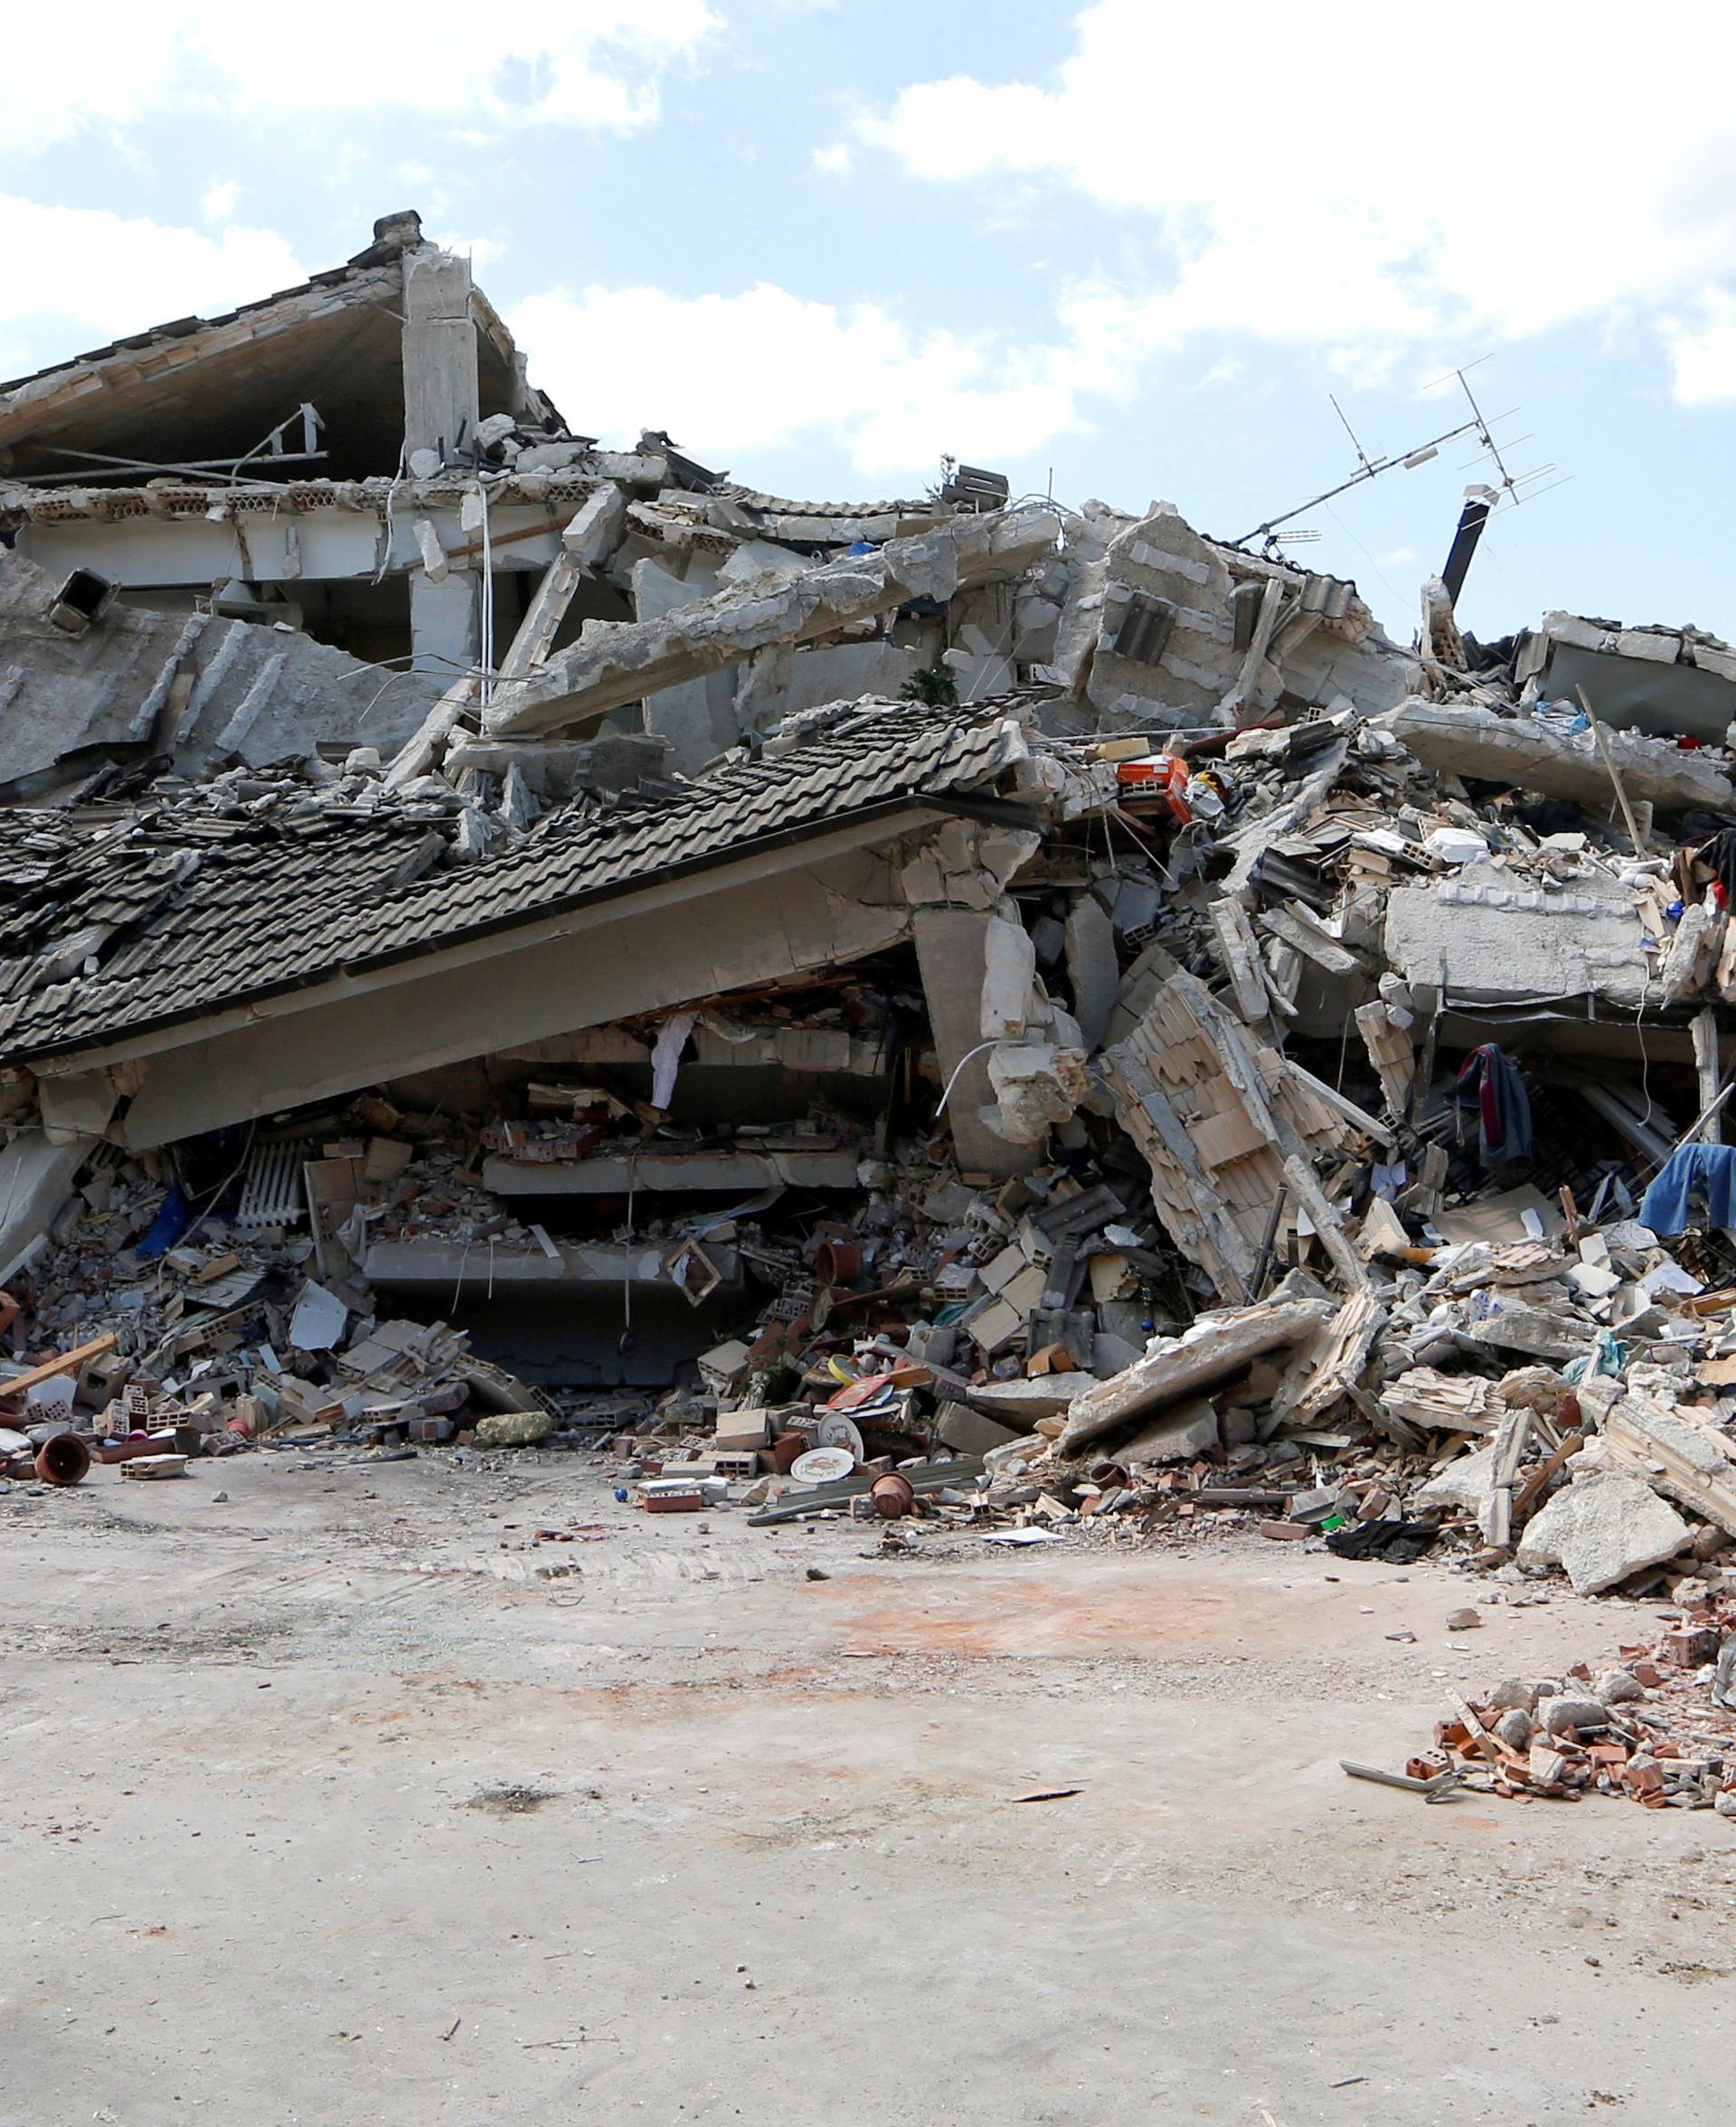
left=855, top=0, right=1736, bottom=400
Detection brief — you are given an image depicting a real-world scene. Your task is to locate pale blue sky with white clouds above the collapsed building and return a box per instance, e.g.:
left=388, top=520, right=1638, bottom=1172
left=0, top=0, right=1736, bottom=636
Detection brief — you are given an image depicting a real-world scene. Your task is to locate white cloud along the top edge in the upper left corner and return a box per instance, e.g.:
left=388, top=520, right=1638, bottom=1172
left=0, top=0, right=723, bottom=153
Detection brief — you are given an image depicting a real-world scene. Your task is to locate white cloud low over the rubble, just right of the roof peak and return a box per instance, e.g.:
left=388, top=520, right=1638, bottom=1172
left=511, top=280, right=1087, bottom=478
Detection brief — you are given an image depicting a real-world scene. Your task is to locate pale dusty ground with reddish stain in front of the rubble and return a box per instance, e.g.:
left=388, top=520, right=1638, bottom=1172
left=0, top=1455, right=1736, bottom=2127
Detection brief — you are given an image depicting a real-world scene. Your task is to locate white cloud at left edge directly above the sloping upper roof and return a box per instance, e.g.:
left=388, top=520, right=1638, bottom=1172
left=0, top=194, right=307, bottom=376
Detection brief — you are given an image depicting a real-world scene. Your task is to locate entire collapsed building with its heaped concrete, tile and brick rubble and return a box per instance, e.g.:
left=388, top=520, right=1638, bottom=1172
left=0, top=215, right=1736, bottom=1676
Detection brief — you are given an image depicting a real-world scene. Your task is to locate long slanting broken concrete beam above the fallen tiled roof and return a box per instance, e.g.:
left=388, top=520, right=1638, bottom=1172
left=487, top=510, right=1055, bottom=732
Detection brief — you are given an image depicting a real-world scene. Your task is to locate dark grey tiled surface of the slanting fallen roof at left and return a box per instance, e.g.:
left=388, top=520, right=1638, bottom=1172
left=0, top=702, right=1008, bottom=1062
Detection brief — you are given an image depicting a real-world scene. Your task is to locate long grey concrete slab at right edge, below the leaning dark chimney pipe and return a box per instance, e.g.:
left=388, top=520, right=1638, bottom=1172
left=1385, top=702, right=1736, bottom=812
